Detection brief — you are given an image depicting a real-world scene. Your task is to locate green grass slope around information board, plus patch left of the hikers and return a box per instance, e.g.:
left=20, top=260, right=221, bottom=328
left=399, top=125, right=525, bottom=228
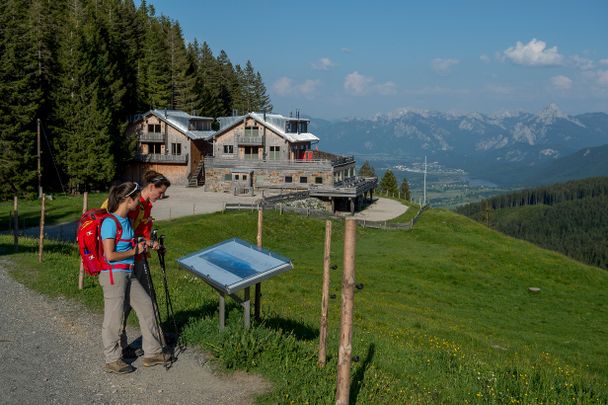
left=0, top=210, right=608, bottom=403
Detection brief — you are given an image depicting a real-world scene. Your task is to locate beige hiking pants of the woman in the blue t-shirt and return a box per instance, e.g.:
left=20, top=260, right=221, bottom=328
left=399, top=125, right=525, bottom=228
left=99, top=271, right=162, bottom=363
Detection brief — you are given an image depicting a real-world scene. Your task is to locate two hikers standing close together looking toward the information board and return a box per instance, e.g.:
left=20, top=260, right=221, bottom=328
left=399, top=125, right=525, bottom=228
left=100, top=171, right=171, bottom=374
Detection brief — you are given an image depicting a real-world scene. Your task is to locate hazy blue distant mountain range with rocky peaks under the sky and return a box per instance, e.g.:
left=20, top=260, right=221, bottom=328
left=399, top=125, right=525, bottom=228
left=310, top=104, right=608, bottom=186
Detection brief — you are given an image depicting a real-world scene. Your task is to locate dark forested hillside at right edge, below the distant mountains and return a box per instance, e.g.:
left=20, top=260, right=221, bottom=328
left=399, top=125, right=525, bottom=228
left=457, top=177, right=608, bottom=269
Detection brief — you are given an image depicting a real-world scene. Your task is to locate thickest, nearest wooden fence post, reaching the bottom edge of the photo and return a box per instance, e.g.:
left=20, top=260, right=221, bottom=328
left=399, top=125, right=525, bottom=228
left=336, top=218, right=357, bottom=405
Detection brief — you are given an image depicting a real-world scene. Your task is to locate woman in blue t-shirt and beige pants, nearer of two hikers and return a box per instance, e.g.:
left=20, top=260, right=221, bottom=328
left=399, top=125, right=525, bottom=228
left=99, top=182, right=170, bottom=374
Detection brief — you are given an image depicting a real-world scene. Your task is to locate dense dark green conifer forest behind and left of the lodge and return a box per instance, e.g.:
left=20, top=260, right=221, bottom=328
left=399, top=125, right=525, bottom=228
left=0, top=0, right=272, bottom=198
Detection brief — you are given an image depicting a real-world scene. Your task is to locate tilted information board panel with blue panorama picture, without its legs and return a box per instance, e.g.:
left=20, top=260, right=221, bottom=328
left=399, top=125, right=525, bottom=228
left=177, top=238, right=293, bottom=294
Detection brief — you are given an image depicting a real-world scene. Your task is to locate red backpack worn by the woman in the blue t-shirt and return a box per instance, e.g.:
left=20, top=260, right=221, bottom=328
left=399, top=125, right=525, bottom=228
left=76, top=208, right=131, bottom=284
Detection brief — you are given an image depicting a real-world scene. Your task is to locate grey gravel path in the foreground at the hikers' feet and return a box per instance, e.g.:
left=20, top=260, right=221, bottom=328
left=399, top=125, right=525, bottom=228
left=0, top=259, right=269, bottom=405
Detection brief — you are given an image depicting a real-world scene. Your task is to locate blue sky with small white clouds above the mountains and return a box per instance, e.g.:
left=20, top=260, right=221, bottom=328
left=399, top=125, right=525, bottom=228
left=148, top=0, right=608, bottom=119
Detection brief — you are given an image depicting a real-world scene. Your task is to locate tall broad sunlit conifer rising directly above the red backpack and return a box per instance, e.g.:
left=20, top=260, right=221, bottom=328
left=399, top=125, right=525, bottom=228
left=55, top=0, right=116, bottom=191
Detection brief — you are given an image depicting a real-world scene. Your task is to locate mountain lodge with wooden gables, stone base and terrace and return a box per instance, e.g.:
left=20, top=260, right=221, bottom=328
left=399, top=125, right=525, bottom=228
left=127, top=110, right=377, bottom=212
